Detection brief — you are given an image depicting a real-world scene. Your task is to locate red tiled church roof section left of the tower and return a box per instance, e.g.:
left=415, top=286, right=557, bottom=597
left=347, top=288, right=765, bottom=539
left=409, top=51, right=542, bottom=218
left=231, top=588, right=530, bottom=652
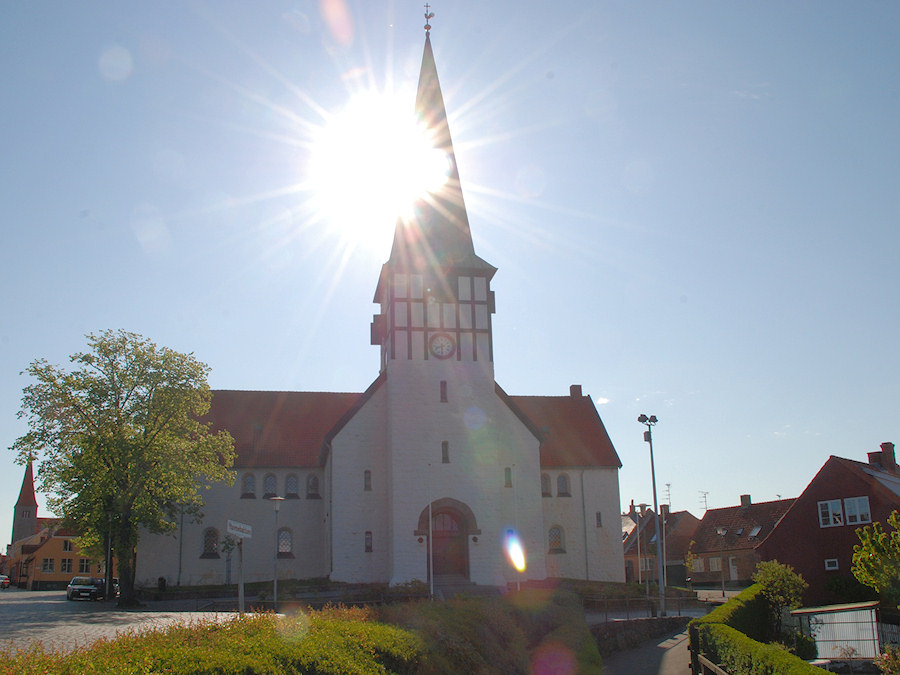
left=205, top=390, right=362, bottom=468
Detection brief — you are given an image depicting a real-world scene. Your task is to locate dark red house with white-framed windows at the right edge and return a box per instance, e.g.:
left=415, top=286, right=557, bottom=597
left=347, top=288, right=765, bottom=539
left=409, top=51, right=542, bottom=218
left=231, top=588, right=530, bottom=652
left=759, top=443, right=900, bottom=605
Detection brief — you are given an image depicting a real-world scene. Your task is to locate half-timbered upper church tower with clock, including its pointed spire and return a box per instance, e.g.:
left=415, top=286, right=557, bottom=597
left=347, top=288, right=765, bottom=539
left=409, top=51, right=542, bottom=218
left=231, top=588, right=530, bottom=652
left=372, top=31, right=497, bottom=379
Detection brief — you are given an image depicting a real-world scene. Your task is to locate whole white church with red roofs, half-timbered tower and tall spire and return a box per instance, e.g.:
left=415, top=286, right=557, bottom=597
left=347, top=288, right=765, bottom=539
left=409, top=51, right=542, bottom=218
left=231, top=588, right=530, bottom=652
left=135, top=26, right=624, bottom=586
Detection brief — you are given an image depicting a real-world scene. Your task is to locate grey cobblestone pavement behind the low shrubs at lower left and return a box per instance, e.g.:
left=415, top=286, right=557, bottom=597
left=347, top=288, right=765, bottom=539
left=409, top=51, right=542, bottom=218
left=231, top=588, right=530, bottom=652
left=0, top=588, right=235, bottom=651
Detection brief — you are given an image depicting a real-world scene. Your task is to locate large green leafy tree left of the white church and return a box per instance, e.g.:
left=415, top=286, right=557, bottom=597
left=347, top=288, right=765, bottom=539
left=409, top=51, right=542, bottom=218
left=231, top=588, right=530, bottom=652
left=12, top=330, right=234, bottom=606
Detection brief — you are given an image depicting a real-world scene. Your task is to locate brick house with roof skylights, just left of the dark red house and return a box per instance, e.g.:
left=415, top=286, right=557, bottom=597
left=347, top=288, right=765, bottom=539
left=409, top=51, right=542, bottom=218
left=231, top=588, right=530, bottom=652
left=690, top=495, right=794, bottom=588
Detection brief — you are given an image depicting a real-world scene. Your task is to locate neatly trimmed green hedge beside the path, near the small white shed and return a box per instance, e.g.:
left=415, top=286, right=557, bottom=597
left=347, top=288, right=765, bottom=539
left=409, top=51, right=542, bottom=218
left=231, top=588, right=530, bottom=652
left=690, top=584, right=825, bottom=675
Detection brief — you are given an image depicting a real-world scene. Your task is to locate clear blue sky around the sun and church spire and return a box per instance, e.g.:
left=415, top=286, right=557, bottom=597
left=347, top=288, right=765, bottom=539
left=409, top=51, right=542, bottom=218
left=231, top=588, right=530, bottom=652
left=0, top=0, right=900, bottom=544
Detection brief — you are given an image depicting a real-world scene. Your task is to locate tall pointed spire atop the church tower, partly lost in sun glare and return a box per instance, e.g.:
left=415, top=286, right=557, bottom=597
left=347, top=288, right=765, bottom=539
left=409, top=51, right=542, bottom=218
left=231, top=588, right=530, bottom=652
left=388, top=28, right=496, bottom=278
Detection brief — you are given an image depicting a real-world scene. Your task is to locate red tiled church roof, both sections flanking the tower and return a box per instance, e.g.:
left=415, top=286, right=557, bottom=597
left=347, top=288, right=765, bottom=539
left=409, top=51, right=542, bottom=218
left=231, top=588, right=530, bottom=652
left=204, top=378, right=622, bottom=468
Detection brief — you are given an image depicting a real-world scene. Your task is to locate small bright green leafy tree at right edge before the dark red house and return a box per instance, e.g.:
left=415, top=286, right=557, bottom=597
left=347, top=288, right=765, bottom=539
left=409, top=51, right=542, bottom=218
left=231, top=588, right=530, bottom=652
left=850, top=511, right=900, bottom=605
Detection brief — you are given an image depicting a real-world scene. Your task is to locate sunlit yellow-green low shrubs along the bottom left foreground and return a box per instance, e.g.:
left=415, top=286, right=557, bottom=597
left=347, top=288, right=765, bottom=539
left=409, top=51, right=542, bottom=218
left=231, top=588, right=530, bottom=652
left=0, top=610, right=424, bottom=675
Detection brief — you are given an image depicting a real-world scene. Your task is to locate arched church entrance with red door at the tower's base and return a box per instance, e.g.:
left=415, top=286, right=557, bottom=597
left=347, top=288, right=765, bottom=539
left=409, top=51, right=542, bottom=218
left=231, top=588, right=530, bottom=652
left=416, top=498, right=481, bottom=580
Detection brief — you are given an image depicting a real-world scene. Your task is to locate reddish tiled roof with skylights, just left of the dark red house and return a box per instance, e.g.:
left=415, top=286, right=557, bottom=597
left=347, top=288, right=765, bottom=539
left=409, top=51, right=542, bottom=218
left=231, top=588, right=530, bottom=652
left=692, top=499, right=795, bottom=553
